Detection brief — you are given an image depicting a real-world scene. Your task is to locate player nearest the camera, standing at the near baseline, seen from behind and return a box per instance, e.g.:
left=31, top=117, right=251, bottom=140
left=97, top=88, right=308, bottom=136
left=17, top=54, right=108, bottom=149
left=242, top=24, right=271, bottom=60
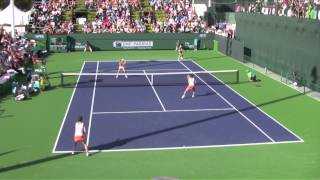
left=72, top=116, right=89, bottom=156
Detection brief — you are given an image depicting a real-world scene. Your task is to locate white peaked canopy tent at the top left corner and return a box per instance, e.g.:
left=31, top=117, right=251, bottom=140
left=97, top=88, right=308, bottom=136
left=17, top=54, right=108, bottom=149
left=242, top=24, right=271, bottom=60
left=0, top=0, right=31, bottom=25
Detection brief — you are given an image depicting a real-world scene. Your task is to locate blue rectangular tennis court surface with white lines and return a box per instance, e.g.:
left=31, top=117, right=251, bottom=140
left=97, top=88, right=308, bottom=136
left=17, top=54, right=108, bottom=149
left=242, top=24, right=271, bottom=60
left=53, top=60, right=303, bottom=153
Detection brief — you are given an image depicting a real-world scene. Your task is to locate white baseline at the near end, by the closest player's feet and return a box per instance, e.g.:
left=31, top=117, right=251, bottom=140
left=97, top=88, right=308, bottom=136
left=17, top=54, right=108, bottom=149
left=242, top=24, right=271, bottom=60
left=54, top=141, right=301, bottom=153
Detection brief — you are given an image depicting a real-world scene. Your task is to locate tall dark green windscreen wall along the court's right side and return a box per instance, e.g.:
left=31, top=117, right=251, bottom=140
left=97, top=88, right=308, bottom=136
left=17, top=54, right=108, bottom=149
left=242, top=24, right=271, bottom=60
left=236, top=13, right=320, bottom=90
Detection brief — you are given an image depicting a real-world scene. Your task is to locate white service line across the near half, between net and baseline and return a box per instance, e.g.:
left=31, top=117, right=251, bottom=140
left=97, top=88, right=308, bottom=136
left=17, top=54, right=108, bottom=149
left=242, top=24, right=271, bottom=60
left=92, top=108, right=234, bottom=115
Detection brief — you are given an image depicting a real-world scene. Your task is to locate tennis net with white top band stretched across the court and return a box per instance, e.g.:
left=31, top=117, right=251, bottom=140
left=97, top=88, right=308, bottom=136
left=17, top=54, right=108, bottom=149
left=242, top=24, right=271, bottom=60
left=61, top=70, right=239, bottom=87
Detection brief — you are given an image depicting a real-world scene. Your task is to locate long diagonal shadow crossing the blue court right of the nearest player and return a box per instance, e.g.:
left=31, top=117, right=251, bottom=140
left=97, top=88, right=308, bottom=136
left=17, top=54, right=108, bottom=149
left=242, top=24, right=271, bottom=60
left=89, top=93, right=304, bottom=150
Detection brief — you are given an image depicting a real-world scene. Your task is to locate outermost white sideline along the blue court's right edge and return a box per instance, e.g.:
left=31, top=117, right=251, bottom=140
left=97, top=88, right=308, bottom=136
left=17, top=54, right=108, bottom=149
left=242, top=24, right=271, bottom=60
left=192, top=61, right=304, bottom=142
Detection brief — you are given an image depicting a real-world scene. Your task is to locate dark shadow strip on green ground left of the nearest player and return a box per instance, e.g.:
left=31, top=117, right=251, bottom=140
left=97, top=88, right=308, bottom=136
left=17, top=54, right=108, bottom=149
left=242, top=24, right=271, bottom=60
left=0, top=154, right=77, bottom=173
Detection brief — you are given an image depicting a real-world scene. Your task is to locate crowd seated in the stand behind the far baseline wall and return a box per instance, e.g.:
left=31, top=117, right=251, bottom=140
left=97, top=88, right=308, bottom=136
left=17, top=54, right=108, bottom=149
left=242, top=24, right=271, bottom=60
left=25, top=0, right=206, bottom=34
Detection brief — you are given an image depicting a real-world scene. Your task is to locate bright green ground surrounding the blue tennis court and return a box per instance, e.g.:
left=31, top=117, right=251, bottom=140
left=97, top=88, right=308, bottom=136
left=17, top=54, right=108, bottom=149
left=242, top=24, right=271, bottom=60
left=0, top=50, right=320, bottom=179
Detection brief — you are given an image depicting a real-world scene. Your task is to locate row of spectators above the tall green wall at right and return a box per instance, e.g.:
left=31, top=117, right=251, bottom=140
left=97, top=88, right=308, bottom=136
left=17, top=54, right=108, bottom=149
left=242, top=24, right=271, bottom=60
left=235, top=0, right=320, bottom=20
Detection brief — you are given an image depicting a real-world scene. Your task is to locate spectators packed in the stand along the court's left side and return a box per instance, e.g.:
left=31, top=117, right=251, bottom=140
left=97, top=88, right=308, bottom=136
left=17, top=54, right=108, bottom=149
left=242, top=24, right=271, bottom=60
left=0, top=27, right=48, bottom=101
